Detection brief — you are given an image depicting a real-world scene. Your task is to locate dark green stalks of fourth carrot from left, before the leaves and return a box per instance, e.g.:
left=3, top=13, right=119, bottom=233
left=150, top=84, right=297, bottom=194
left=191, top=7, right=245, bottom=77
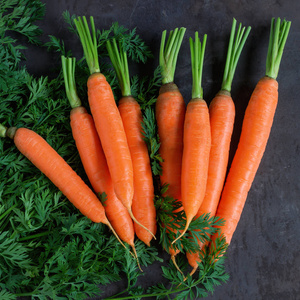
left=106, top=39, right=131, bottom=97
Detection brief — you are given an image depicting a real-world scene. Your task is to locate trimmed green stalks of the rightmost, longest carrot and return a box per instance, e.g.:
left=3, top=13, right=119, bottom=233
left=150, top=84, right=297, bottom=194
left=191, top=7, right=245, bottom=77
left=266, top=18, right=291, bottom=79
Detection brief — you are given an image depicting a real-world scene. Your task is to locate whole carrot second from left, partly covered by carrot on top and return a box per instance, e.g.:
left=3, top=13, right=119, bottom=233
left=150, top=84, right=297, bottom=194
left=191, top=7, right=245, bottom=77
left=61, top=56, right=141, bottom=266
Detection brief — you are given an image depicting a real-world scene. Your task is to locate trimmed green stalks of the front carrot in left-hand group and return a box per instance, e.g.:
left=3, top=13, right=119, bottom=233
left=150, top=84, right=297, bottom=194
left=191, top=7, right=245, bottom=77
left=74, top=16, right=100, bottom=74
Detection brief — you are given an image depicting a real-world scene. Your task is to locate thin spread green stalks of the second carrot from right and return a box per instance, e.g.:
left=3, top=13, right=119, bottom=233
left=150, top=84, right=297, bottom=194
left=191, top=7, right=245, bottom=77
left=221, top=19, right=251, bottom=93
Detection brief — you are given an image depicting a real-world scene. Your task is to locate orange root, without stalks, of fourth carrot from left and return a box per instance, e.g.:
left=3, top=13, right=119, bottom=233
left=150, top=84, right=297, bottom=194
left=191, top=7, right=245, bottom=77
left=118, top=96, right=157, bottom=245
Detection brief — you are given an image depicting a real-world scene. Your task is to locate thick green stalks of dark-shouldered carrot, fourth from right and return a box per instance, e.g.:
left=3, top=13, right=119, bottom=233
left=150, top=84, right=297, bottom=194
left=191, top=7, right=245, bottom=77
left=159, top=27, right=186, bottom=84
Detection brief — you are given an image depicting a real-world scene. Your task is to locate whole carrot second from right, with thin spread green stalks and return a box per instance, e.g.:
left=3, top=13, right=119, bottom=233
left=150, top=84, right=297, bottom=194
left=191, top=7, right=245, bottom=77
left=186, top=19, right=251, bottom=276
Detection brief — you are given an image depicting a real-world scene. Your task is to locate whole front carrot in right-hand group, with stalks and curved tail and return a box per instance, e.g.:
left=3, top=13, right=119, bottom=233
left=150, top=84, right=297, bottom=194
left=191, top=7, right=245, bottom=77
left=172, top=32, right=211, bottom=243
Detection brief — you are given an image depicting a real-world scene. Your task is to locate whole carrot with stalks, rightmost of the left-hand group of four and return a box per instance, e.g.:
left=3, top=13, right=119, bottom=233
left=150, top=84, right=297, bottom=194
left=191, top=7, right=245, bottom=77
left=107, top=39, right=157, bottom=246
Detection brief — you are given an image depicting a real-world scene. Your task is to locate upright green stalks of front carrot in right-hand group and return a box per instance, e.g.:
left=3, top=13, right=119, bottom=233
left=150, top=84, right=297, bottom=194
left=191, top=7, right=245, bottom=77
left=190, top=31, right=207, bottom=99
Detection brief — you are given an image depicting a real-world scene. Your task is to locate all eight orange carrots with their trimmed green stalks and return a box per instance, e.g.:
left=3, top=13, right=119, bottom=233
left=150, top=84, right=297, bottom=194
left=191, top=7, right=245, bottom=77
left=0, top=17, right=291, bottom=282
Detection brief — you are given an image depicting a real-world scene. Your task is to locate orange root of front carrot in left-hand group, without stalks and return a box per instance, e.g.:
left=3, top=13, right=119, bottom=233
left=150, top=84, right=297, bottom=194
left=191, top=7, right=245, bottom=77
left=87, top=73, right=133, bottom=210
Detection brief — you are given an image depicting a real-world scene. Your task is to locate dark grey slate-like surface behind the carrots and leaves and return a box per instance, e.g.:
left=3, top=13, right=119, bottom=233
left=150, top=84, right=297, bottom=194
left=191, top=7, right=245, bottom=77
left=27, top=0, right=300, bottom=300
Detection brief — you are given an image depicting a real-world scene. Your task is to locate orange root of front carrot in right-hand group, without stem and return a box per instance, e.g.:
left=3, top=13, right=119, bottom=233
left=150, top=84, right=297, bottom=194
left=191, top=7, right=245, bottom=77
left=181, top=99, right=211, bottom=224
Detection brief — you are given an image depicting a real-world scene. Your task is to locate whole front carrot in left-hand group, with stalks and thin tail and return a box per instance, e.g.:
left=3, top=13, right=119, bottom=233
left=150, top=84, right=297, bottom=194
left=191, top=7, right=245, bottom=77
left=74, top=17, right=156, bottom=238
